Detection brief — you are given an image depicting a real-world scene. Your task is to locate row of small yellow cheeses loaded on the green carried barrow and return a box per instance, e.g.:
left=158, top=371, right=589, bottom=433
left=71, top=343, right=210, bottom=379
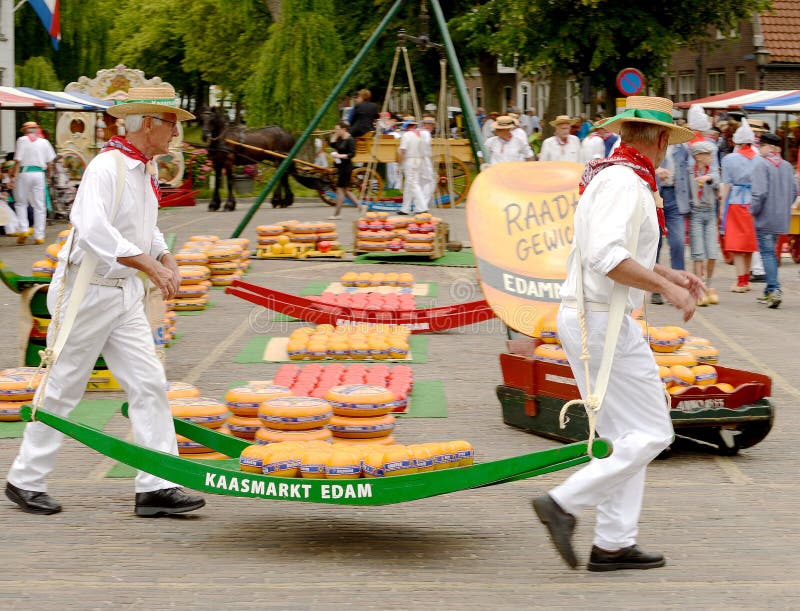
left=239, top=440, right=475, bottom=479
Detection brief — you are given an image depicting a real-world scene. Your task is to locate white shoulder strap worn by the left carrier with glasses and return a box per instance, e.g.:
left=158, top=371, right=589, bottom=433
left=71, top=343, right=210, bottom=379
left=33, top=150, right=125, bottom=415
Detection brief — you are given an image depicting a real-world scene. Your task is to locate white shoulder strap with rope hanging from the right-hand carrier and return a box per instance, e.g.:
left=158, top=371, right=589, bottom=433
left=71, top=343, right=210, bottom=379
left=559, top=187, right=644, bottom=456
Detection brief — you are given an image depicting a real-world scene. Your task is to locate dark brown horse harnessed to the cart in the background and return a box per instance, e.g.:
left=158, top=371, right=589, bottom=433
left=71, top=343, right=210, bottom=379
left=199, top=107, right=294, bottom=210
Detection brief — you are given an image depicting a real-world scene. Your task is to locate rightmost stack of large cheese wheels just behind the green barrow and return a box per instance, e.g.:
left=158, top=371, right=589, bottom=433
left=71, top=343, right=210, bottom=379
left=325, top=384, right=396, bottom=445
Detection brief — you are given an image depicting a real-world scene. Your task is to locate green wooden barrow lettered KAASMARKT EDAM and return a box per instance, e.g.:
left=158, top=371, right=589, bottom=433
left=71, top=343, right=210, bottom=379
left=21, top=406, right=611, bottom=505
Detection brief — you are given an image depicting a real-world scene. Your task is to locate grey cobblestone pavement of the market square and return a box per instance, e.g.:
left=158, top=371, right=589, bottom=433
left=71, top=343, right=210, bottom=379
left=0, top=200, right=800, bottom=610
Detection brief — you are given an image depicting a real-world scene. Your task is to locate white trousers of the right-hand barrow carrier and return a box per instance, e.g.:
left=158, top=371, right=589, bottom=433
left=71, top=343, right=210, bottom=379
left=550, top=305, right=673, bottom=551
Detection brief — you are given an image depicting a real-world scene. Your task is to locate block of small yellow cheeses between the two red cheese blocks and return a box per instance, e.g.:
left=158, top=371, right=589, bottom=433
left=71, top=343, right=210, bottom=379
left=286, top=323, right=411, bottom=361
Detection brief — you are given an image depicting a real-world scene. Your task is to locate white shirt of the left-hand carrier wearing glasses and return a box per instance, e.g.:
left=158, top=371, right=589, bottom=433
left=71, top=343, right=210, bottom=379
left=62, top=152, right=167, bottom=278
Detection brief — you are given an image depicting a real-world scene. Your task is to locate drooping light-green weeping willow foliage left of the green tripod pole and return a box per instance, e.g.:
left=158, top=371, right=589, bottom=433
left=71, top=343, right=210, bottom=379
left=246, top=0, right=344, bottom=131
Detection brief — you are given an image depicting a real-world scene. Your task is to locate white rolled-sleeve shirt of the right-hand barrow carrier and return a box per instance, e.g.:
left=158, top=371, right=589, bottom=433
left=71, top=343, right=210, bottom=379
left=561, top=165, right=659, bottom=309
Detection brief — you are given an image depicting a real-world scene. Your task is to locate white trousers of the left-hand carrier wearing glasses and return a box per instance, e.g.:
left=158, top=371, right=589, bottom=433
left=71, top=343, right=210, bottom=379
left=8, top=271, right=178, bottom=492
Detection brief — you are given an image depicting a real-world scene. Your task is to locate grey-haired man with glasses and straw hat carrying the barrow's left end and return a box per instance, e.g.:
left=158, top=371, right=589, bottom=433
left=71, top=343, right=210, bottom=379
left=6, top=86, right=205, bottom=517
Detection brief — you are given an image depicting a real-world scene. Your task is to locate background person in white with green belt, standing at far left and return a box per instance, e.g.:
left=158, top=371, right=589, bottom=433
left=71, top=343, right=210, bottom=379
left=13, top=121, right=56, bottom=245
